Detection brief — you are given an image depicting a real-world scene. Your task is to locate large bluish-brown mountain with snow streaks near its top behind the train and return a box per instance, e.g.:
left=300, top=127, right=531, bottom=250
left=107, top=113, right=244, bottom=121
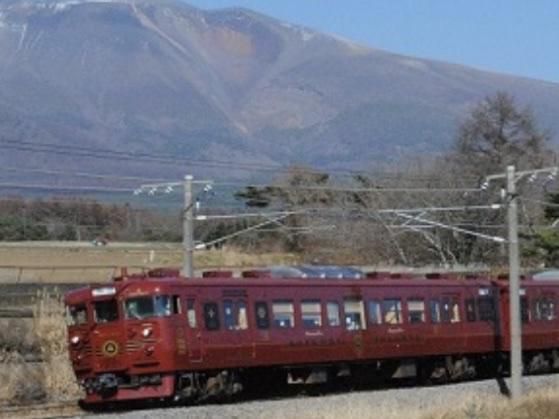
left=0, top=0, right=559, bottom=182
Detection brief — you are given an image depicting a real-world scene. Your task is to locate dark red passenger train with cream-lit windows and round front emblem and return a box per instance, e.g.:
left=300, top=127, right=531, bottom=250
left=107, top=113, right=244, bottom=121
left=65, top=270, right=559, bottom=405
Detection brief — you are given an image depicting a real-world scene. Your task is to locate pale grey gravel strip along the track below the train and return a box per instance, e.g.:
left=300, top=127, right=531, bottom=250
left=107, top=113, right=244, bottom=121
left=80, top=375, right=559, bottom=419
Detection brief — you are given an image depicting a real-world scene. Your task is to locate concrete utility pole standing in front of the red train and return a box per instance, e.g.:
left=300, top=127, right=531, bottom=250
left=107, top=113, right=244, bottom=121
left=507, top=166, right=522, bottom=399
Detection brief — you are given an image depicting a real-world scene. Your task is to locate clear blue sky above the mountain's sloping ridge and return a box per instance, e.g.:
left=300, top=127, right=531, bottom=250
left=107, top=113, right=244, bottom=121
left=187, top=0, right=559, bottom=82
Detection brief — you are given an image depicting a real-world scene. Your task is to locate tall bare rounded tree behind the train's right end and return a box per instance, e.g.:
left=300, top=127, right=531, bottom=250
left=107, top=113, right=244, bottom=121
left=449, top=92, right=553, bottom=262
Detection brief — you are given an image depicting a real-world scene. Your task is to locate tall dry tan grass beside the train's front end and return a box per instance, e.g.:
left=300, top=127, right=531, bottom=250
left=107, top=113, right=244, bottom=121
left=0, top=293, right=80, bottom=404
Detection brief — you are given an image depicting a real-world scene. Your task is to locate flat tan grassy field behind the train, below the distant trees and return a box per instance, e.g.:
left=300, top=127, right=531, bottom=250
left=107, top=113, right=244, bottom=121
left=0, top=242, right=298, bottom=283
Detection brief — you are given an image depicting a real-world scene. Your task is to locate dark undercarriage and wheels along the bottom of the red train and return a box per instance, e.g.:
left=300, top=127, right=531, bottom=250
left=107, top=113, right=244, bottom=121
left=82, top=349, right=559, bottom=408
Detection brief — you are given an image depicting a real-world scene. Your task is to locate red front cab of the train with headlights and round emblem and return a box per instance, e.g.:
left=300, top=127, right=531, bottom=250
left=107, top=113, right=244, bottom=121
left=66, top=283, right=180, bottom=405
